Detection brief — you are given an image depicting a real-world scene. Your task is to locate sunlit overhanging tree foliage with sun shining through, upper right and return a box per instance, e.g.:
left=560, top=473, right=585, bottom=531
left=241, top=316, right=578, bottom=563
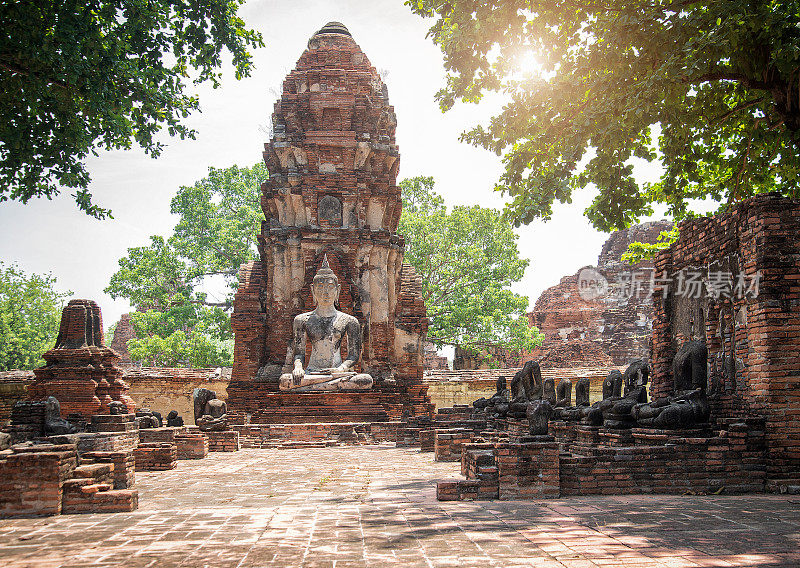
left=406, top=0, right=800, bottom=231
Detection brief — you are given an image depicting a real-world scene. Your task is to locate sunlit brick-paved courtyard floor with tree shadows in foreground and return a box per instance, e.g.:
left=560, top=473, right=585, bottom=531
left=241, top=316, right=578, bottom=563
left=0, top=445, right=800, bottom=568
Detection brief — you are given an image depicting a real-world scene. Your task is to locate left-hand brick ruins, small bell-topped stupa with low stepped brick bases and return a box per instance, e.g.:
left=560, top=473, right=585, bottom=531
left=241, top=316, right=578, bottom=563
left=0, top=300, right=239, bottom=518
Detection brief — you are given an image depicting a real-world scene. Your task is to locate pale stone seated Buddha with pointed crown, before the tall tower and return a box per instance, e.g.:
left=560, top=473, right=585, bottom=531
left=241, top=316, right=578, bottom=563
left=280, top=256, right=373, bottom=392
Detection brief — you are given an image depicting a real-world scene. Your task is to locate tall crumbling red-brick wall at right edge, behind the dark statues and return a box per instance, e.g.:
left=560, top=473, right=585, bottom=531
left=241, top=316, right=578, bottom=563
left=651, top=194, right=800, bottom=483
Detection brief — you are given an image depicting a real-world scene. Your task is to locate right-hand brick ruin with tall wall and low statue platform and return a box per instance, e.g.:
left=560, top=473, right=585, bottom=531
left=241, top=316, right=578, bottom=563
left=422, top=194, right=800, bottom=500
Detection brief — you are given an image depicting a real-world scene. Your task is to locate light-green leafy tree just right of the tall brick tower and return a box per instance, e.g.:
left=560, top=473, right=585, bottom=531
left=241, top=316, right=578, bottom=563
left=398, top=176, right=543, bottom=351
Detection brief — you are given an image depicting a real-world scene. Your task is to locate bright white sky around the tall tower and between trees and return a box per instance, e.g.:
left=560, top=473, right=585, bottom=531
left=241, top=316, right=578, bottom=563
left=0, top=0, right=658, bottom=327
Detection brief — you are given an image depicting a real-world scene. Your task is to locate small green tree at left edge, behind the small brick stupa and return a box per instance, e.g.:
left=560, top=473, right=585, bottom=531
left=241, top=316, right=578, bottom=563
left=0, top=262, right=72, bottom=371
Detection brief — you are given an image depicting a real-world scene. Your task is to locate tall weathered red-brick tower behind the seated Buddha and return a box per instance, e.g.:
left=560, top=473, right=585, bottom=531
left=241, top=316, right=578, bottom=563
left=228, top=22, right=432, bottom=423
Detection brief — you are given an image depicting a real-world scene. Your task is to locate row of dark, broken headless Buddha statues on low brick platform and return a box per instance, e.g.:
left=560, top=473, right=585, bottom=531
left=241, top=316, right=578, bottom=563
left=473, top=341, right=710, bottom=436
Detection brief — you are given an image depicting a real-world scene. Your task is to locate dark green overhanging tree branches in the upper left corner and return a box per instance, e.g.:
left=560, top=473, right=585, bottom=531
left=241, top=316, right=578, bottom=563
left=0, top=0, right=263, bottom=218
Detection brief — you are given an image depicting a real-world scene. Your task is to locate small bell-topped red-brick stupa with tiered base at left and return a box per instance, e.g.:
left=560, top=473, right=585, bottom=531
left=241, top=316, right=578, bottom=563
left=28, top=300, right=135, bottom=420
